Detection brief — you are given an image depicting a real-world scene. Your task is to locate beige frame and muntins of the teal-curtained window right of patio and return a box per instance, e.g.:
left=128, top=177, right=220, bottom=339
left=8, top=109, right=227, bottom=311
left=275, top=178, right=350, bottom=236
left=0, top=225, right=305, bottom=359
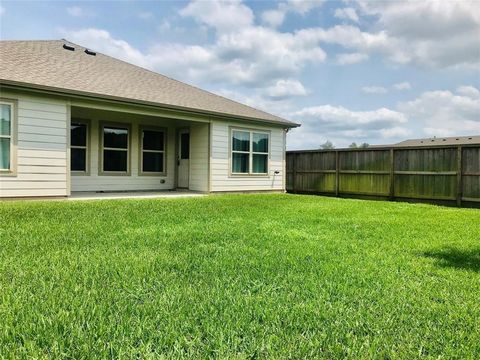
left=228, top=127, right=271, bottom=177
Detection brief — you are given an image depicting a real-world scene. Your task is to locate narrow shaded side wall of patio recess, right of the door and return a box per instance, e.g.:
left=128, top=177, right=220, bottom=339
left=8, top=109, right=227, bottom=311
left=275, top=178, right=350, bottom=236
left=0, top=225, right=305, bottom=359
left=189, top=124, right=209, bottom=192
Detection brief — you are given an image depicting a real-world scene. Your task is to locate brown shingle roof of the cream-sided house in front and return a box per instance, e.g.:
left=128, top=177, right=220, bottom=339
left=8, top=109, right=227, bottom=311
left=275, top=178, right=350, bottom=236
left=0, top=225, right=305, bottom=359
left=0, top=40, right=299, bottom=127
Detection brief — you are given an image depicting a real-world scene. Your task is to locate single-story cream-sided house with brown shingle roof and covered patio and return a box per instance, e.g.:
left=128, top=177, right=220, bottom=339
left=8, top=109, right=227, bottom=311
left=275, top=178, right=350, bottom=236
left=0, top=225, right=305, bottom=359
left=0, top=40, right=298, bottom=198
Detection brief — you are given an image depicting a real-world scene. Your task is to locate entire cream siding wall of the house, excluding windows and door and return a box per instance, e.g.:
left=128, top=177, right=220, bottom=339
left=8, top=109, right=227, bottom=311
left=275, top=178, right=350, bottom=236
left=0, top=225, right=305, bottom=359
left=0, top=91, right=285, bottom=197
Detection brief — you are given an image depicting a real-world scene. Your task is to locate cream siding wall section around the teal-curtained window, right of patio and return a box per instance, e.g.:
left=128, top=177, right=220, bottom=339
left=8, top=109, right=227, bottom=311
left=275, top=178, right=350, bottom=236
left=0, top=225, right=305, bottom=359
left=210, top=121, right=285, bottom=192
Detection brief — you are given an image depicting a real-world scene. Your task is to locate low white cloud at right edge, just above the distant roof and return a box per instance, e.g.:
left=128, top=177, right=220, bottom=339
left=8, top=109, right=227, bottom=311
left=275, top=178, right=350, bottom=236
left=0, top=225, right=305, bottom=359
left=399, top=86, right=480, bottom=136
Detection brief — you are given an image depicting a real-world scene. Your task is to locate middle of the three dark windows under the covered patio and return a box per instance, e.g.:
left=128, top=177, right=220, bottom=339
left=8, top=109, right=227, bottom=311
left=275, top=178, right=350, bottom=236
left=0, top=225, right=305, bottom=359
left=101, top=125, right=130, bottom=175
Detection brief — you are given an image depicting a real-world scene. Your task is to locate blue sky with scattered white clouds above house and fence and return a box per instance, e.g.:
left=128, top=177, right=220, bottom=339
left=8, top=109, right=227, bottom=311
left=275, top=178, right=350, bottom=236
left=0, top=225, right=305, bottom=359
left=0, top=0, right=480, bottom=149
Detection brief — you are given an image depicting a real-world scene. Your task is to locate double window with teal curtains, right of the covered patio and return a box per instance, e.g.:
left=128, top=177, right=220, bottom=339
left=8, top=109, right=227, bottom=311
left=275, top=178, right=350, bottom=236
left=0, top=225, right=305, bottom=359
left=232, top=130, right=269, bottom=174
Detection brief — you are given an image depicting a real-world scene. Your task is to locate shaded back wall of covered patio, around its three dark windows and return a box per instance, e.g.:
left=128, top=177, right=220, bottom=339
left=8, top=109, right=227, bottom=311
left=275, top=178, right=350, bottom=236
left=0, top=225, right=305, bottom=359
left=71, top=108, right=176, bottom=191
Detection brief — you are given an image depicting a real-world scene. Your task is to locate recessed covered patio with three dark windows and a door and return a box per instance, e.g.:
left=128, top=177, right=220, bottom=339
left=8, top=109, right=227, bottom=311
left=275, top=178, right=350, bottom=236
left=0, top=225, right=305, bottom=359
left=70, top=102, right=209, bottom=195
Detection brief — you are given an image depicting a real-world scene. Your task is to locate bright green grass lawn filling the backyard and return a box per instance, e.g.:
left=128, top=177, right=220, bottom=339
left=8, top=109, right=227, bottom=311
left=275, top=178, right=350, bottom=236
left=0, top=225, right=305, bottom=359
left=0, top=195, right=480, bottom=359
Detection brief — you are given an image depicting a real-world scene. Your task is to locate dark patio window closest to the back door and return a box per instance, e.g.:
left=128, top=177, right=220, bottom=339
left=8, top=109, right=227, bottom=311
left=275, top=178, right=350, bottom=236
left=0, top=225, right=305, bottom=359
left=140, top=128, right=165, bottom=174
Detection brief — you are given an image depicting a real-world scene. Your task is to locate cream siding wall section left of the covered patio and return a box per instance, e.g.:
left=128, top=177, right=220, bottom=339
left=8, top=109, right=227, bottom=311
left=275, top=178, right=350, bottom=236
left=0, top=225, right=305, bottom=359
left=0, top=90, right=69, bottom=197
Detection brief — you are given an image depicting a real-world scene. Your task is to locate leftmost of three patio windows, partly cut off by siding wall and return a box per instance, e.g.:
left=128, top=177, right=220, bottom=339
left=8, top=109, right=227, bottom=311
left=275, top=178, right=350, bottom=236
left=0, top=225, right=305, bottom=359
left=70, top=120, right=88, bottom=173
